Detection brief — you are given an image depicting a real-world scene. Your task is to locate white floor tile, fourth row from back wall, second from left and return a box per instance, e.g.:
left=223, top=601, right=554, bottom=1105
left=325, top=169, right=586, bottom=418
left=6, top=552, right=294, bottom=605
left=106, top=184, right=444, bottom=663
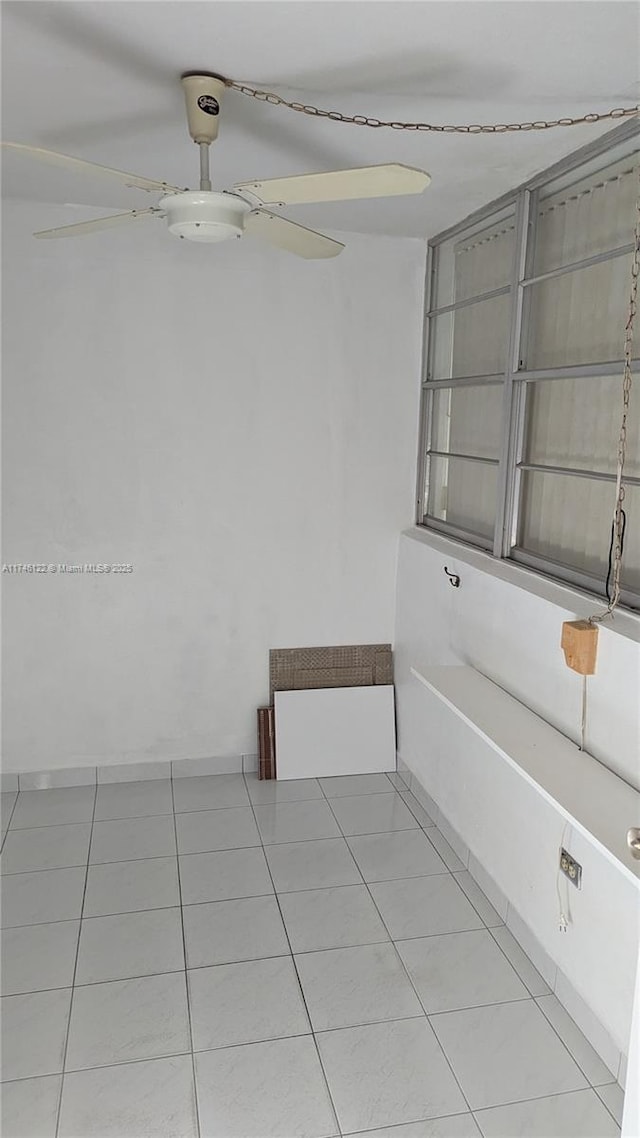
left=75, top=908, right=184, bottom=984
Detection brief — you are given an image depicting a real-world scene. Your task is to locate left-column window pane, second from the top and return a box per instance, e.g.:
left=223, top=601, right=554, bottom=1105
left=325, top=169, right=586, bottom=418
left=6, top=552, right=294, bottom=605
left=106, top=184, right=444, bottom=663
left=432, top=294, right=509, bottom=379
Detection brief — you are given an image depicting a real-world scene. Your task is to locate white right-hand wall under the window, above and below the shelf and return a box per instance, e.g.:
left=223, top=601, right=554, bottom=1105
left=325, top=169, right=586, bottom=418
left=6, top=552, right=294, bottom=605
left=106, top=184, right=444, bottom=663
left=395, top=530, right=640, bottom=1053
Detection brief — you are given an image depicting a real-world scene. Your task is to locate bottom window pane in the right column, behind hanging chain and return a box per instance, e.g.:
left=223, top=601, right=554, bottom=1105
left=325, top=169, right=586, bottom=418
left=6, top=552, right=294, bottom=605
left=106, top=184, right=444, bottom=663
left=518, top=471, right=640, bottom=591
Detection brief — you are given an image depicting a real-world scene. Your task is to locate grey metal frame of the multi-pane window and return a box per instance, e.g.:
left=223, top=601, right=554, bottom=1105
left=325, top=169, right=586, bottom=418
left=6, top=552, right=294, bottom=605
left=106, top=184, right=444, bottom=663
left=416, top=119, right=640, bottom=608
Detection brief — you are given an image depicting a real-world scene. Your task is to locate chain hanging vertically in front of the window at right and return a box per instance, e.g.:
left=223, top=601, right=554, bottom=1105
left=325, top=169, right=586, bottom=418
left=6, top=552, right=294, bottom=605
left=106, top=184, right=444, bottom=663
left=589, top=177, right=640, bottom=624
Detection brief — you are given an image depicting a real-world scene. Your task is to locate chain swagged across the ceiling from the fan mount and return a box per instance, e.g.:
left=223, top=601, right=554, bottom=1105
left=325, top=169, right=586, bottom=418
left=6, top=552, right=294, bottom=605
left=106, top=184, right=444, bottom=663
left=224, top=79, right=640, bottom=134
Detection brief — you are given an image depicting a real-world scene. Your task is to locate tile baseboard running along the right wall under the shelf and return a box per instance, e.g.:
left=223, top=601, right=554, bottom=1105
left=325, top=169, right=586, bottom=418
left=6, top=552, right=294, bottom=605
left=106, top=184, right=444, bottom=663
left=397, top=756, right=627, bottom=1086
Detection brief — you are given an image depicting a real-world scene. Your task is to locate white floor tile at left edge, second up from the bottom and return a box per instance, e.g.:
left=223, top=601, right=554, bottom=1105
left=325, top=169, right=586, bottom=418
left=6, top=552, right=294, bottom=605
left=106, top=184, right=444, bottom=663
left=1, top=988, right=71, bottom=1079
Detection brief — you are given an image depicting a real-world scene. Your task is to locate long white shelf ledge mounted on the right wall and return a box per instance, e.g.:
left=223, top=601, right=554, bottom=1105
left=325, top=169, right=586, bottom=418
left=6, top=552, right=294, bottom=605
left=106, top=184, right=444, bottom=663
left=411, top=666, right=640, bottom=884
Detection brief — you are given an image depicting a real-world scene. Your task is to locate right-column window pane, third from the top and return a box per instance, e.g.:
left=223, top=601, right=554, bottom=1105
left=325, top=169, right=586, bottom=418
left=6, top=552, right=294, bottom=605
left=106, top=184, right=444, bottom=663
left=524, top=374, right=640, bottom=478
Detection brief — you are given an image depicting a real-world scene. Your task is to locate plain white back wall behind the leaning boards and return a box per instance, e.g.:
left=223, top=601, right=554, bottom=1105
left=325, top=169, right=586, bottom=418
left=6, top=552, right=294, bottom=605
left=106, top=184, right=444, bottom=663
left=2, top=203, right=425, bottom=772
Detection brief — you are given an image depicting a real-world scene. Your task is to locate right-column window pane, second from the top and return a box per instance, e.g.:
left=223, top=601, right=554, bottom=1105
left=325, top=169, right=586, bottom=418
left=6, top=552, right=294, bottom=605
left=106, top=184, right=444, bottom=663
left=524, top=255, right=631, bottom=369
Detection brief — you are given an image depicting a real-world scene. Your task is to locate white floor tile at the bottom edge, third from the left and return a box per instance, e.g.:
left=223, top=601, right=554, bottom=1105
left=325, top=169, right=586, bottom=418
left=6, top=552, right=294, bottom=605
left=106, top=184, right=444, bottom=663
left=196, top=1036, right=338, bottom=1138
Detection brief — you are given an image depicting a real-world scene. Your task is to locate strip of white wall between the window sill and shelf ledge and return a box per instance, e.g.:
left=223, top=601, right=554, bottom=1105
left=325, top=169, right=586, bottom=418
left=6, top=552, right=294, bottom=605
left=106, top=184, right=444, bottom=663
left=396, top=528, right=640, bottom=789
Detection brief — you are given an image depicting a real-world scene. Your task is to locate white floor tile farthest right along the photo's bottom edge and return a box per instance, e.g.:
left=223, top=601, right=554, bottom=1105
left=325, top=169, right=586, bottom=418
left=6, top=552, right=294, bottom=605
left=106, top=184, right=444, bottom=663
left=476, top=1090, right=620, bottom=1138
